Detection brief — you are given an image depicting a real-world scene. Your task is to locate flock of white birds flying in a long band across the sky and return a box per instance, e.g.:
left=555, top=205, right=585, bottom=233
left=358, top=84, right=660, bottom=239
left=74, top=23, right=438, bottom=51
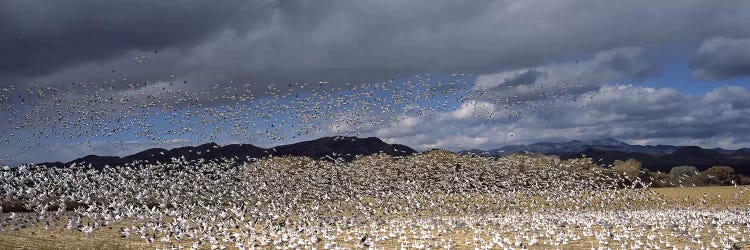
left=0, top=71, right=652, bottom=162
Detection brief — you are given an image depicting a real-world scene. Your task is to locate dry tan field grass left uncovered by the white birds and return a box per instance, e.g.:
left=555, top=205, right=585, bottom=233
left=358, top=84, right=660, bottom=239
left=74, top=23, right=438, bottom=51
left=0, top=186, right=750, bottom=249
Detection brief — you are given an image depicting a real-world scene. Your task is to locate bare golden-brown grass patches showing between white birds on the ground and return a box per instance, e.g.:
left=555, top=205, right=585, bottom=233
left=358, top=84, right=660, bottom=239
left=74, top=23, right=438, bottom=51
left=0, top=186, right=750, bottom=249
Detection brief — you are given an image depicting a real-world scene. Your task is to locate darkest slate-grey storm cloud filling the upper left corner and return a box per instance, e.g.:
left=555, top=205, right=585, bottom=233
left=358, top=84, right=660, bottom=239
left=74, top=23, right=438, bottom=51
left=0, top=0, right=270, bottom=78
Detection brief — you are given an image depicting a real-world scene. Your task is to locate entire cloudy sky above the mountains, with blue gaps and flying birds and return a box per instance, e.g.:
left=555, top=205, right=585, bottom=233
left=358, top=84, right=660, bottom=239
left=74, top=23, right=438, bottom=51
left=0, top=0, right=750, bottom=164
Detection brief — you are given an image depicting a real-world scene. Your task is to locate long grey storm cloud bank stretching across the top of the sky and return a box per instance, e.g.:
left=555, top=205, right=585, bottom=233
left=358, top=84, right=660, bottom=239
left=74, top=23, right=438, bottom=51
left=5, top=0, right=750, bottom=84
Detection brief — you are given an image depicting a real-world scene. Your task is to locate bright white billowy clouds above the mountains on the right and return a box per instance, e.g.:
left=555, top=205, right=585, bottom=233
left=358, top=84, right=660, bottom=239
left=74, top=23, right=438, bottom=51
left=378, top=85, right=750, bottom=150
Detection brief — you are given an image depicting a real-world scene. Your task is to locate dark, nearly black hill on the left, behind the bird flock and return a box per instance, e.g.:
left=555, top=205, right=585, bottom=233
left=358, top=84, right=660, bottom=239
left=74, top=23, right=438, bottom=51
left=37, top=136, right=417, bottom=168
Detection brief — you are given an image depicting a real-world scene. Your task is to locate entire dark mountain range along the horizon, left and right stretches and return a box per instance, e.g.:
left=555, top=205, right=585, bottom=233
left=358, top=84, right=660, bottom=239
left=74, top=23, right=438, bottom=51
left=37, top=136, right=750, bottom=175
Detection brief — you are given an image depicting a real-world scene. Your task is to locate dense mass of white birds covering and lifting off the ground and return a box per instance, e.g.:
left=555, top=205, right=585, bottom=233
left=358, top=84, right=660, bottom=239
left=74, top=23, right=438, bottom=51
left=0, top=151, right=750, bottom=249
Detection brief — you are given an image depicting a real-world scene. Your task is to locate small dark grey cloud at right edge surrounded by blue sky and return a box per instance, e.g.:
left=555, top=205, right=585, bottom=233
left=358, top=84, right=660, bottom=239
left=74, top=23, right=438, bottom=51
left=690, top=37, right=750, bottom=80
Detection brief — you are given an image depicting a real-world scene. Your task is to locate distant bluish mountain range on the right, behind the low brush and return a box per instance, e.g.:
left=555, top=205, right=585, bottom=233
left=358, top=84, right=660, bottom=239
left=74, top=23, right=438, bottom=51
left=459, top=138, right=750, bottom=175
